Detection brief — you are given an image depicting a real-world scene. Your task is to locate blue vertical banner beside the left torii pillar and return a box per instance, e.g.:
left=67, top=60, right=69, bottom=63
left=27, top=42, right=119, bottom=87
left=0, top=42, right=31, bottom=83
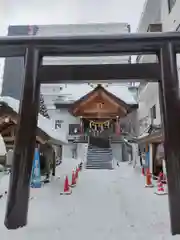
left=31, top=148, right=41, bottom=188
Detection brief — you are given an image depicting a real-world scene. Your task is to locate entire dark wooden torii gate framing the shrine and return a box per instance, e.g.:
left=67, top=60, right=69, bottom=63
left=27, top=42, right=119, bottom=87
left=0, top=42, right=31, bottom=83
left=0, top=32, right=180, bottom=235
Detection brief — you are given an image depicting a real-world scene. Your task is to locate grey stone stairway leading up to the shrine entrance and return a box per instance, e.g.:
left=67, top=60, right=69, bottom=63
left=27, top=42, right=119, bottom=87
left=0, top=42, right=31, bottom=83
left=86, top=137, right=113, bottom=169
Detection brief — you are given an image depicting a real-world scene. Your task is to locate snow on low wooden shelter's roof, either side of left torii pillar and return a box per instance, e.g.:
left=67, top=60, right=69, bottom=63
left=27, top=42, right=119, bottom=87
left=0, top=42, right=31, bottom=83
left=0, top=96, right=68, bottom=144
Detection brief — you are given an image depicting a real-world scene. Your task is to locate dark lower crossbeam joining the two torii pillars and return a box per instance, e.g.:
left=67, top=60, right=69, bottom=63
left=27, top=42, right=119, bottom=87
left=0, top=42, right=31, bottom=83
left=38, top=63, right=161, bottom=83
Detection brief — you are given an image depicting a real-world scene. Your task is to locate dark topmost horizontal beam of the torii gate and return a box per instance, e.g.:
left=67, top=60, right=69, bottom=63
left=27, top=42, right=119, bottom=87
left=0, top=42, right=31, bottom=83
left=0, top=32, right=180, bottom=57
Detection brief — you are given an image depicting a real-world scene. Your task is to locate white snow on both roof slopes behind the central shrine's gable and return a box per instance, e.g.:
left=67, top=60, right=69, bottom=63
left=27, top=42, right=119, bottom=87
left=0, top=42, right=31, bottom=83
left=54, top=83, right=137, bottom=104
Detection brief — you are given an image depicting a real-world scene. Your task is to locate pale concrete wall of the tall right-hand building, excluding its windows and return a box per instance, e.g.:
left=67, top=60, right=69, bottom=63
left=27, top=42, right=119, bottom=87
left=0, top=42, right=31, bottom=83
left=138, top=0, right=180, bottom=137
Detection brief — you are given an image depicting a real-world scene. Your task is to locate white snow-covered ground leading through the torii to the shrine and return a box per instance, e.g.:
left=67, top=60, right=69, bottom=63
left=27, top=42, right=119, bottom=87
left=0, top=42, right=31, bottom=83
left=0, top=163, right=177, bottom=240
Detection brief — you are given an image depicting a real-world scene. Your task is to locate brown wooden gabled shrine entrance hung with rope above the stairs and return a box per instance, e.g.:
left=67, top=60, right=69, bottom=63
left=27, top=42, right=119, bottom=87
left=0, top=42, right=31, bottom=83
left=69, top=84, right=137, bottom=138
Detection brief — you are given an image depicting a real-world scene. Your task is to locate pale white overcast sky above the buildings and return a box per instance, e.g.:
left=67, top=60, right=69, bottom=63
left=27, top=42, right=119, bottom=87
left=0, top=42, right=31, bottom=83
left=0, top=0, right=145, bottom=92
